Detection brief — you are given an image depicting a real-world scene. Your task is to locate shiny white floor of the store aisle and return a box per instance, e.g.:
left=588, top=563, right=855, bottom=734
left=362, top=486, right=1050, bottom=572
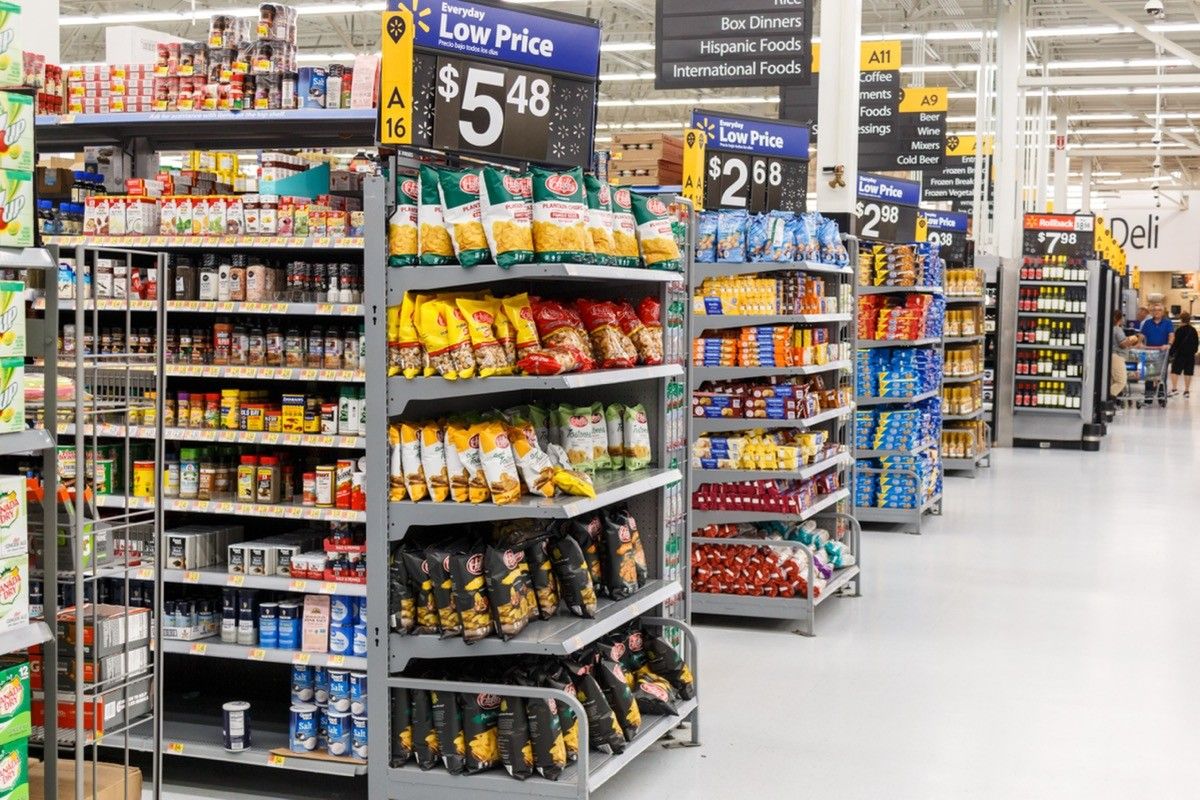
left=598, top=407, right=1200, bottom=800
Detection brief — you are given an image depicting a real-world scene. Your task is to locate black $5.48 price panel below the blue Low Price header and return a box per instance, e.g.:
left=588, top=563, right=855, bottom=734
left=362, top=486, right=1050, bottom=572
left=433, top=58, right=553, bottom=161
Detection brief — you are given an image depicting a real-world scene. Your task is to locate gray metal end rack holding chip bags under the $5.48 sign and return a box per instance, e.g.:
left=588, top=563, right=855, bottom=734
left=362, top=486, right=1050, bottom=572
left=365, top=176, right=700, bottom=799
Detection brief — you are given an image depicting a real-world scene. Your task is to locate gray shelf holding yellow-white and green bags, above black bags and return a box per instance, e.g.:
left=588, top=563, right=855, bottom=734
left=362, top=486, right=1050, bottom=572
left=389, top=469, right=683, bottom=541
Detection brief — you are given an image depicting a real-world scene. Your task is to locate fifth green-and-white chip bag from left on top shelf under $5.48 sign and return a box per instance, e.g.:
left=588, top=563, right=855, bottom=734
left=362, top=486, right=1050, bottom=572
left=533, top=167, right=592, bottom=264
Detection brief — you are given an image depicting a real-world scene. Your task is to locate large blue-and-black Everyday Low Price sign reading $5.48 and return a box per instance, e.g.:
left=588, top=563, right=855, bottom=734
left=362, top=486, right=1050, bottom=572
left=383, top=0, right=600, bottom=167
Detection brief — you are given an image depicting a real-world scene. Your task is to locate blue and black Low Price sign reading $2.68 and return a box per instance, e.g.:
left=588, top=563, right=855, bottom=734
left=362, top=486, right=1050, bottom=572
left=691, top=109, right=809, bottom=213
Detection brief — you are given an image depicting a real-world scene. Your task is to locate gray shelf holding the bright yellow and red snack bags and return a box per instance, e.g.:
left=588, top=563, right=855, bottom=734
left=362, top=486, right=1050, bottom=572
left=388, top=363, right=684, bottom=416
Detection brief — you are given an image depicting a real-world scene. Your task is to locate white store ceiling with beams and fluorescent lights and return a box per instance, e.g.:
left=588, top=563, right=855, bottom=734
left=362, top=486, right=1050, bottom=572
left=61, top=0, right=1200, bottom=188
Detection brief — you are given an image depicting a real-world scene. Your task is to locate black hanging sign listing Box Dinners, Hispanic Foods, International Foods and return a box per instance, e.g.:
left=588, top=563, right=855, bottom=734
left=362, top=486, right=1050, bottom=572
left=654, top=0, right=812, bottom=89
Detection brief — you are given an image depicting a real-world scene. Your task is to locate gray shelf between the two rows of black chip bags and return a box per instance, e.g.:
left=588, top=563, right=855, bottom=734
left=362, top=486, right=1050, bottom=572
left=391, top=579, right=683, bottom=672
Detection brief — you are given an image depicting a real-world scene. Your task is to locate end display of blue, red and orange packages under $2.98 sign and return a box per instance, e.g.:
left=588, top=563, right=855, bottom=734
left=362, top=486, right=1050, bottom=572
left=853, top=243, right=945, bottom=533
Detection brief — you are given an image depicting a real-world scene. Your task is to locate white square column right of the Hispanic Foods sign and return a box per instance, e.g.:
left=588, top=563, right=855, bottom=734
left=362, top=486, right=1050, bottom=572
left=817, top=0, right=863, bottom=215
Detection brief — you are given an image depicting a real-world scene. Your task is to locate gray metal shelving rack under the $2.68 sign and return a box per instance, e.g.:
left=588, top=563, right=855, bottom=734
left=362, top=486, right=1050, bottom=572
left=688, top=236, right=862, bottom=636
